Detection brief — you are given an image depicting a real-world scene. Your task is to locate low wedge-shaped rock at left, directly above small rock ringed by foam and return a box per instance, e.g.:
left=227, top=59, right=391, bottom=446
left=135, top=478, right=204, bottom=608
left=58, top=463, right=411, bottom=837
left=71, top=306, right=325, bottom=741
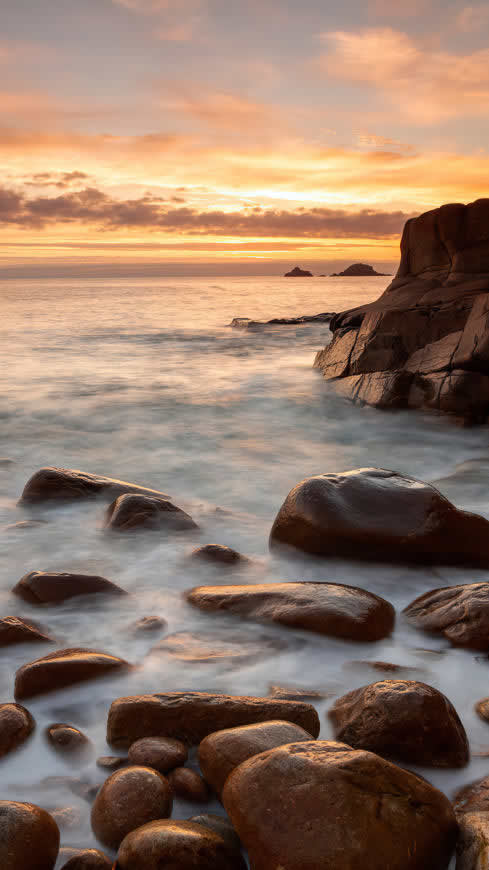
left=15, top=647, right=131, bottom=701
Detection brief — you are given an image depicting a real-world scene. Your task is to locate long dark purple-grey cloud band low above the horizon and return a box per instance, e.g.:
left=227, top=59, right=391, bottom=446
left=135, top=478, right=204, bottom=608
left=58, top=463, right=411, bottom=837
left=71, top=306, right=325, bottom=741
left=0, top=187, right=411, bottom=238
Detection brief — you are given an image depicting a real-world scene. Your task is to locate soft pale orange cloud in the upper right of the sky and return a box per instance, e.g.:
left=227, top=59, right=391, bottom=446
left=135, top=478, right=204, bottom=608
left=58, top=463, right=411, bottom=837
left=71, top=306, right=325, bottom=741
left=320, top=27, right=489, bottom=124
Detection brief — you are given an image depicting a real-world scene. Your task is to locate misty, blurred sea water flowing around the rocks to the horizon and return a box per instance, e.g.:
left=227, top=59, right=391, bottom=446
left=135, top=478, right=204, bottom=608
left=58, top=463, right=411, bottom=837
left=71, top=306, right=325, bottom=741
left=0, top=278, right=489, bottom=860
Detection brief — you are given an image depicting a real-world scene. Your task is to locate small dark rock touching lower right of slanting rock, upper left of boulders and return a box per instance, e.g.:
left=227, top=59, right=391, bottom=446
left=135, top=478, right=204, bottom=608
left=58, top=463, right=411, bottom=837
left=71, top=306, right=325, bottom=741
left=105, top=493, right=198, bottom=532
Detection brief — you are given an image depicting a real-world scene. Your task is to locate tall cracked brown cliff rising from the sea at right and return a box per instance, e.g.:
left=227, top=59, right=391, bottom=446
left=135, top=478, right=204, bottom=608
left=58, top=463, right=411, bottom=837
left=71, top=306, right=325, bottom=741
left=314, top=199, right=489, bottom=422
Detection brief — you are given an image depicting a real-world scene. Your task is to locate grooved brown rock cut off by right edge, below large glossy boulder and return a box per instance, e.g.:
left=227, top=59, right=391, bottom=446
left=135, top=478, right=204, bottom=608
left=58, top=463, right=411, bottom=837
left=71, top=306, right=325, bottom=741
left=404, top=583, right=489, bottom=652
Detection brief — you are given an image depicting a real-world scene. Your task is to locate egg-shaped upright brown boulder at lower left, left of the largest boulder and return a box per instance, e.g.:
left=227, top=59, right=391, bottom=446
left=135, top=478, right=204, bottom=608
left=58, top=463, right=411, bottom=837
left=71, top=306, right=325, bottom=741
left=92, top=766, right=172, bottom=849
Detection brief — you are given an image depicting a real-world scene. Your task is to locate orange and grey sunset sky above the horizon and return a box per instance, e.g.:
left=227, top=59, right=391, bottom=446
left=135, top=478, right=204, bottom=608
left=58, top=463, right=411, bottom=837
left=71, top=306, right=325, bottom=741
left=0, top=0, right=489, bottom=276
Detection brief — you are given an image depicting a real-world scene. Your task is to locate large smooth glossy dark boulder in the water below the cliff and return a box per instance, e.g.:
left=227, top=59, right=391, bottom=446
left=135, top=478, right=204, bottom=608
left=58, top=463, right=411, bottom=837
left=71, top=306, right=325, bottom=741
left=270, top=468, right=489, bottom=567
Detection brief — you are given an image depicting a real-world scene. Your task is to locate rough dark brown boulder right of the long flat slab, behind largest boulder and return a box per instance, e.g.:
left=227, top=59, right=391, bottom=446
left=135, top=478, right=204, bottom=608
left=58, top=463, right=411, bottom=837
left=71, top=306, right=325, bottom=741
left=328, top=680, right=469, bottom=767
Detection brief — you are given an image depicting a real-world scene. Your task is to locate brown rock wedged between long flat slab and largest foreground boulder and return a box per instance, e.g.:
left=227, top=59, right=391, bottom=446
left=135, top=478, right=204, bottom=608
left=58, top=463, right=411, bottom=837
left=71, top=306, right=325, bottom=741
left=199, top=720, right=311, bottom=794
